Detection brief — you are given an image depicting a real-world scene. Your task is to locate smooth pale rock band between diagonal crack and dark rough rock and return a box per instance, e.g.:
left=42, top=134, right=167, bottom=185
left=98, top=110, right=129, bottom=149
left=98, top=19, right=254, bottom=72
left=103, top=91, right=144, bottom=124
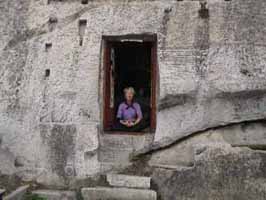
left=149, top=121, right=266, bottom=168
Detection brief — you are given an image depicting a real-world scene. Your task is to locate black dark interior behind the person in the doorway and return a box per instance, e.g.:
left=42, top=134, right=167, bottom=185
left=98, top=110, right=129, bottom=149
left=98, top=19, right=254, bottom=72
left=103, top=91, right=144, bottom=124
left=113, top=42, right=152, bottom=130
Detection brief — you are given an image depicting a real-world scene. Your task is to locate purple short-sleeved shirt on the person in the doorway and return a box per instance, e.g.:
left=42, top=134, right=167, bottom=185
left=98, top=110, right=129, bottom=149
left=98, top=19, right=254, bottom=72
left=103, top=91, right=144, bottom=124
left=116, top=102, right=142, bottom=120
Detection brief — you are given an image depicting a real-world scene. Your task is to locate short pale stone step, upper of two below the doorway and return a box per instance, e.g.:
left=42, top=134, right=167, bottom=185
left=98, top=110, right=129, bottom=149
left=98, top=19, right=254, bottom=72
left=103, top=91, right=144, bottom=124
left=106, top=174, right=151, bottom=189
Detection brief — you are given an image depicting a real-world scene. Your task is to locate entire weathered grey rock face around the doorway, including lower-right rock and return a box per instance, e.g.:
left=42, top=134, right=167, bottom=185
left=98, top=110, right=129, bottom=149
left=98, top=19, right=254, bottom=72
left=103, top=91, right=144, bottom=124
left=0, top=0, right=266, bottom=199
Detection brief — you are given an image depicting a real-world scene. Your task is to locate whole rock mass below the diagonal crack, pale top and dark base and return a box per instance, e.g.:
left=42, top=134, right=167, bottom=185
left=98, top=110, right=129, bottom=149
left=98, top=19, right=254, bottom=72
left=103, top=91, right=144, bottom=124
left=149, top=122, right=266, bottom=200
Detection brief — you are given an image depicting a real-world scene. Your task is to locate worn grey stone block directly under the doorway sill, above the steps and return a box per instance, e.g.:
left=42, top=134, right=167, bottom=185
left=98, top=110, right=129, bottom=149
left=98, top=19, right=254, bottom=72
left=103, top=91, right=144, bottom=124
left=98, top=134, right=154, bottom=174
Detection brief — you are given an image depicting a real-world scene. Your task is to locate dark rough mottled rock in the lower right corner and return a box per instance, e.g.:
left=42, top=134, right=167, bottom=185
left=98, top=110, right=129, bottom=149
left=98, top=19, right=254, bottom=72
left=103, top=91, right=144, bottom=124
left=153, top=147, right=266, bottom=200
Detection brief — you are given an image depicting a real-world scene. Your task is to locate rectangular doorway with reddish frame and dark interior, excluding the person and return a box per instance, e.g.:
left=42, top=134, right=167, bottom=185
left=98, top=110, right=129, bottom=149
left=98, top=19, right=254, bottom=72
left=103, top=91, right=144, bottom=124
left=103, top=35, right=157, bottom=134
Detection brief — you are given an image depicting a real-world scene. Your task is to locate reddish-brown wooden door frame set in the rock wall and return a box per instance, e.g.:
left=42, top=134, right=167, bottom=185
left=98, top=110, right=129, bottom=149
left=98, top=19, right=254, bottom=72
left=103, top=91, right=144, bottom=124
left=102, top=34, right=158, bottom=134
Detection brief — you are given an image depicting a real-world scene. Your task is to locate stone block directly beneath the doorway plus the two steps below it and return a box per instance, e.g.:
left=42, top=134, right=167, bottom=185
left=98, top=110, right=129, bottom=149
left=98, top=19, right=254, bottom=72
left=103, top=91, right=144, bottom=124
left=86, top=134, right=157, bottom=200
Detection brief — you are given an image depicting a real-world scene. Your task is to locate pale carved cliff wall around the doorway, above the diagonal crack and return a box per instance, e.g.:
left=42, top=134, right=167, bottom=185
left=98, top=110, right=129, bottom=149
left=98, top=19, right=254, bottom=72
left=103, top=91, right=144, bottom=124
left=0, top=0, right=266, bottom=195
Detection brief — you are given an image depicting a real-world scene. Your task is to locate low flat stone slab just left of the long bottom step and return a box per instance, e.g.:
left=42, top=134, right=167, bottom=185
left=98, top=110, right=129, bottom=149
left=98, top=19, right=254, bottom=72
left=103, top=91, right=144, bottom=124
left=32, top=190, right=77, bottom=200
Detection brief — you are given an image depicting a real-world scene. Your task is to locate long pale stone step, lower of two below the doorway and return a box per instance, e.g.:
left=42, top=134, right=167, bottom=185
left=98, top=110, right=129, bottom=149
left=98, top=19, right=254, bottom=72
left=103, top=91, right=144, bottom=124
left=81, top=187, right=157, bottom=200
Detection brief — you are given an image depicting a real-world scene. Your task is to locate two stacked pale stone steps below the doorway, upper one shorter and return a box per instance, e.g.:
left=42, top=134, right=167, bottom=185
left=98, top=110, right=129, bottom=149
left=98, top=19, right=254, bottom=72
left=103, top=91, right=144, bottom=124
left=81, top=174, right=157, bottom=200
